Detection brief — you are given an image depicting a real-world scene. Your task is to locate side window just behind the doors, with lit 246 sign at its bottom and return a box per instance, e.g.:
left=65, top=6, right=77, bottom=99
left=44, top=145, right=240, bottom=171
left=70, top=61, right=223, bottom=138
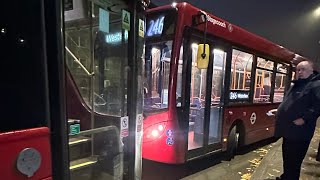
left=229, top=49, right=253, bottom=102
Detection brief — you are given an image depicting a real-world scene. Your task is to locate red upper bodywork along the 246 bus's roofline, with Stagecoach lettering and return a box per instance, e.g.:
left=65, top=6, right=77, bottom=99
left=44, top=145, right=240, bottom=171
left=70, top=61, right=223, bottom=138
left=148, top=3, right=307, bottom=63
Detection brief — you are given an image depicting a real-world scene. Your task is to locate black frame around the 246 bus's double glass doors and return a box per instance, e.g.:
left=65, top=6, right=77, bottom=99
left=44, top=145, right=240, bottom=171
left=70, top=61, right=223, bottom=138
left=179, top=28, right=231, bottom=160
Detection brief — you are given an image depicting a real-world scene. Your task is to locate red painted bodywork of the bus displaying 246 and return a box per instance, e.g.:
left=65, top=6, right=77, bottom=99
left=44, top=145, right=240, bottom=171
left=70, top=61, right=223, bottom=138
left=142, top=3, right=307, bottom=164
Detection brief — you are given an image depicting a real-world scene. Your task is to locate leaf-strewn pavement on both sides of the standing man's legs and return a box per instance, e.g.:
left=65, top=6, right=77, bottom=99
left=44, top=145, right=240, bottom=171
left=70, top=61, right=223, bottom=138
left=250, top=119, right=320, bottom=180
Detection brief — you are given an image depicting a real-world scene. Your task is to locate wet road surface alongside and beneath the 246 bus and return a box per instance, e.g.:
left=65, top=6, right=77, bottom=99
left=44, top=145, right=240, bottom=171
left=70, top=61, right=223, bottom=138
left=142, top=139, right=274, bottom=180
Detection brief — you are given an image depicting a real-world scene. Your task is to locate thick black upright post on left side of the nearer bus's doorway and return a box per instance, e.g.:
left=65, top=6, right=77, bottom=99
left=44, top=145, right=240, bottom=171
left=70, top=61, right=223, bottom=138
left=44, top=0, right=70, bottom=180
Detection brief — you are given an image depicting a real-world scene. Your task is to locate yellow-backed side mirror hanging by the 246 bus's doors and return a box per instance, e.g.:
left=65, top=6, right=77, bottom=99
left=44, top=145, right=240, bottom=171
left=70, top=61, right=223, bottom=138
left=197, top=44, right=210, bottom=69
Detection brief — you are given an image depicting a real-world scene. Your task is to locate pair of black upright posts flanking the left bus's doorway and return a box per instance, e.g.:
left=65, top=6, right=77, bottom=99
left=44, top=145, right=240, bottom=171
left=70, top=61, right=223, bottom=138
left=42, top=0, right=143, bottom=180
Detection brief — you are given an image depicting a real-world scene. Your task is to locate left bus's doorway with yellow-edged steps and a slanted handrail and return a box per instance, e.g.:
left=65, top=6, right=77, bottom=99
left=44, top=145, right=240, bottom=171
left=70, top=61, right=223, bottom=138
left=62, top=0, right=144, bottom=180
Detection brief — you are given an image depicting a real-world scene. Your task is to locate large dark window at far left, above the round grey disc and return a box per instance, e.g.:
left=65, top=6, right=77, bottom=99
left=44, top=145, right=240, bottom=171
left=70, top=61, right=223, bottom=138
left=0, top=1, right=49, bottom=131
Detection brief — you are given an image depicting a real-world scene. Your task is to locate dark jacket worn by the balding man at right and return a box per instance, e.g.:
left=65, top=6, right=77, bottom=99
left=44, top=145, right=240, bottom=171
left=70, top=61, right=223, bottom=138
left=275, top=75, right=320, bottom=141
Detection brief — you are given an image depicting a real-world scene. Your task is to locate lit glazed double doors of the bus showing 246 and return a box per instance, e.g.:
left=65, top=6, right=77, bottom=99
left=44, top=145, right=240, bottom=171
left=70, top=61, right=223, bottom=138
left=184, top=32, right=227, bottom=159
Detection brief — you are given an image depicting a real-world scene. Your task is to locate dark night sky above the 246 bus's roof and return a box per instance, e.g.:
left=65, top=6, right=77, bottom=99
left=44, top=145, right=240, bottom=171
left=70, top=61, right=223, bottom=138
left=151, top=0, right=320, bottom=64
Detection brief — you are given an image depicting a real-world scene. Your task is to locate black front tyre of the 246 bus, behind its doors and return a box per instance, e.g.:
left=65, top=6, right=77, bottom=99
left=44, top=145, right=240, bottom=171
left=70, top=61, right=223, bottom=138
left=227, top=126, right=239, bottom=160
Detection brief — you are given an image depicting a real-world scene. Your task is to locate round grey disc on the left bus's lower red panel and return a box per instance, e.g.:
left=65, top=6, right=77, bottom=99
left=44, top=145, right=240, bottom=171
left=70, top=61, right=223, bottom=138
left=17, top=148, right=41, bottom=178
